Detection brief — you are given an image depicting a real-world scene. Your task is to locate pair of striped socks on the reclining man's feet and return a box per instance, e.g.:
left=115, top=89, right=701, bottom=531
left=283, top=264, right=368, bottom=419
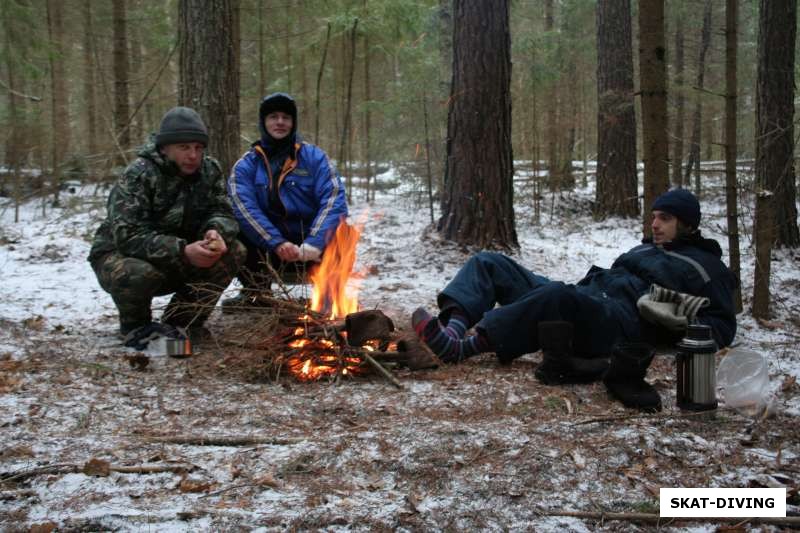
left=411, top=307, right=489, bottom=363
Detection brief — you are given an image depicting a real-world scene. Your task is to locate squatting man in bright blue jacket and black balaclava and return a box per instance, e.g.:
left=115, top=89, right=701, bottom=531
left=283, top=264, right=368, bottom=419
left=223, top=93, right=347, bottom=309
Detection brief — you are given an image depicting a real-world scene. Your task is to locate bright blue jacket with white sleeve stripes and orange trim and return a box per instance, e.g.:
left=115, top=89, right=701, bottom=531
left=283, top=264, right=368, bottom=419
left=228, top=142, right=347, bottom=251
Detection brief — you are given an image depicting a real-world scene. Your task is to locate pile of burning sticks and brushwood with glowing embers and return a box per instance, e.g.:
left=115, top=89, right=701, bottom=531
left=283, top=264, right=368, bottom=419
left=209, top=297, right=440, bottom=387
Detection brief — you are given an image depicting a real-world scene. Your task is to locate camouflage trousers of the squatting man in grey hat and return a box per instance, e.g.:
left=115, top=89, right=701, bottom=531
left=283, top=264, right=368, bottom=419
left=92, top=241, right=247, bottom=333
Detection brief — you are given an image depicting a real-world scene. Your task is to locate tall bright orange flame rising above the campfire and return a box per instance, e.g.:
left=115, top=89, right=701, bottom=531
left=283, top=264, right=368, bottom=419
left=310, top=221, right=361, bottom=319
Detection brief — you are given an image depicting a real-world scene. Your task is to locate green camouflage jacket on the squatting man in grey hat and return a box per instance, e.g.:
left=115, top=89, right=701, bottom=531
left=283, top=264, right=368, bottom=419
left=89, top=137, right=239, bottom=270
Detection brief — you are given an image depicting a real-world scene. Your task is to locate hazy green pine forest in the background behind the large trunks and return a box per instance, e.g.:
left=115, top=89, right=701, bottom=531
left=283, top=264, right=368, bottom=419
left=0, top=0, right=788, bottom=189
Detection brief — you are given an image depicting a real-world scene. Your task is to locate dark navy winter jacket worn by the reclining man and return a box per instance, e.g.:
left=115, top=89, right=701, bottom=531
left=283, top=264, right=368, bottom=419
left=577, top=232, right=736, bottom=346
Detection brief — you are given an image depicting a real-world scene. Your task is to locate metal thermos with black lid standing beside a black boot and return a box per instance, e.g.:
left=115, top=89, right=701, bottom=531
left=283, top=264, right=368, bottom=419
left=676, top=324, right=717, bottom=411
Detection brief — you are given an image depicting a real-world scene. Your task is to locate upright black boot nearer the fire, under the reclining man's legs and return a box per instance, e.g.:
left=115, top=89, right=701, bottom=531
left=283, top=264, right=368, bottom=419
left=534, top=321, right=608, bottom=385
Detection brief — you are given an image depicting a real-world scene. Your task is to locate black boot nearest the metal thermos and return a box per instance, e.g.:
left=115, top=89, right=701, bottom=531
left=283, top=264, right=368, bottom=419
left=603, top=342, right=661, bottom=413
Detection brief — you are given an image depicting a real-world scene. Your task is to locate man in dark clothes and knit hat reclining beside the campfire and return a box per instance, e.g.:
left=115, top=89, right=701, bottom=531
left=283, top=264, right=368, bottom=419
left=412, top=189, right=736, bottom=410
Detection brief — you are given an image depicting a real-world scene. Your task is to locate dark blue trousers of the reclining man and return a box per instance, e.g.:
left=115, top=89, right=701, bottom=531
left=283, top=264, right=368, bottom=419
left=438, top=252, right=638, bottom=359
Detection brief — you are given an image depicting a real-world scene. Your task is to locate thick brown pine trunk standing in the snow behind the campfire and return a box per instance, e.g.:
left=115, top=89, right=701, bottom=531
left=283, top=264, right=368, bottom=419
left=439, top=0, right=518, bottom=249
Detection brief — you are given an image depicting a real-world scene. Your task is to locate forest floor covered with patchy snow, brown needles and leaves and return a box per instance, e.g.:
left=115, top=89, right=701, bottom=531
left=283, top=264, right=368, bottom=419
left=0, top=167, right=800, bottom=531
